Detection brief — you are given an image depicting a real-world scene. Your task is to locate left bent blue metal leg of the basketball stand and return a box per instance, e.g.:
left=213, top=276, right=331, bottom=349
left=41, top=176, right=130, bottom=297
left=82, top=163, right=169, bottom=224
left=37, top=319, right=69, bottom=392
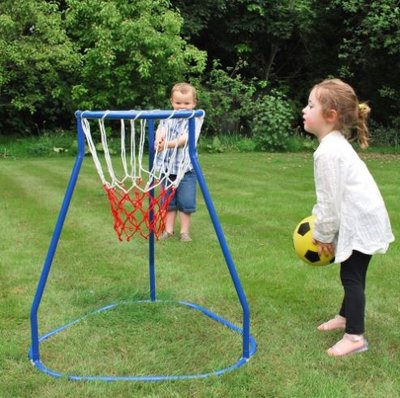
left=30, top=111, right=85, bottom=361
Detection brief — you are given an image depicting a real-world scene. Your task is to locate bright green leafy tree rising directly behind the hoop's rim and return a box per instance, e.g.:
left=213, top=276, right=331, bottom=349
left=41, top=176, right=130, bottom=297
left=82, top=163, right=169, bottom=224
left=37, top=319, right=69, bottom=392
left=66, top=0, right=206, bottom=109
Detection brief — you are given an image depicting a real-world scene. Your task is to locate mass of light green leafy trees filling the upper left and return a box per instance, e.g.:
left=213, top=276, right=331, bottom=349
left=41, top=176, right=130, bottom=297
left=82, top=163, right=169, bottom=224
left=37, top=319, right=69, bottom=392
left=0, top=0, right=206, bottom=134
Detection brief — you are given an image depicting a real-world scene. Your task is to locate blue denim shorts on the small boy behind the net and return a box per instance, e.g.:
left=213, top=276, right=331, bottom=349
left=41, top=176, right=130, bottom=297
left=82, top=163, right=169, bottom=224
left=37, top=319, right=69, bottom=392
left=168, top=171, right=197, bottom=213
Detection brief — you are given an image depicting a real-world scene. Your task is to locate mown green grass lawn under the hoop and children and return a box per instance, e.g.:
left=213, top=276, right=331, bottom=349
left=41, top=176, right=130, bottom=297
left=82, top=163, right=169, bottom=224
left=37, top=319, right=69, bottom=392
left=0, top=153, right=400, bottom=398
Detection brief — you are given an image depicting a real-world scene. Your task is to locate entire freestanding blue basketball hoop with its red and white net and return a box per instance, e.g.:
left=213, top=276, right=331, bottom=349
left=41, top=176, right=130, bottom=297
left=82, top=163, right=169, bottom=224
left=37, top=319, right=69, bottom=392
left=28, top=110, right=257, bottom=381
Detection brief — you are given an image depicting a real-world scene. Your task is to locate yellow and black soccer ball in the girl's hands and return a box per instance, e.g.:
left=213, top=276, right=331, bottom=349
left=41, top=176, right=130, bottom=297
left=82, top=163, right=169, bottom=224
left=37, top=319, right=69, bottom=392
left=293, top=215, right=335, bottom=266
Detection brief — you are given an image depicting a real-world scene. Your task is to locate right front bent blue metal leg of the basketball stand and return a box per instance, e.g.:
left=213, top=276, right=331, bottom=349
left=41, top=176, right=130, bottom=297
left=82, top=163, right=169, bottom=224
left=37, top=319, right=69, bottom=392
left=189, top=117, right=250, bottom=358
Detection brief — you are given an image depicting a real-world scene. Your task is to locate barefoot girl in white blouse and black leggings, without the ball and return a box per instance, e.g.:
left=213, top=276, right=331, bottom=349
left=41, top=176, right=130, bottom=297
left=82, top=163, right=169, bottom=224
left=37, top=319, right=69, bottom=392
left=303, top=79, right=394, bottom=356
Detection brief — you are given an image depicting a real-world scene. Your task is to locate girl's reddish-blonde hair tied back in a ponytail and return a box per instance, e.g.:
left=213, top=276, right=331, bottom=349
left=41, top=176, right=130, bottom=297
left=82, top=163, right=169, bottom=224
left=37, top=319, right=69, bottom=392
left=313, top=79, right=371, bottom=148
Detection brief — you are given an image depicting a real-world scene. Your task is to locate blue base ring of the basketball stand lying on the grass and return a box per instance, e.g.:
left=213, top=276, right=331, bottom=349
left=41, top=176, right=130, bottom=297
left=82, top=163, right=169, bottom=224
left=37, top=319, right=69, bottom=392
left=28, top=300, right=257, bottom=381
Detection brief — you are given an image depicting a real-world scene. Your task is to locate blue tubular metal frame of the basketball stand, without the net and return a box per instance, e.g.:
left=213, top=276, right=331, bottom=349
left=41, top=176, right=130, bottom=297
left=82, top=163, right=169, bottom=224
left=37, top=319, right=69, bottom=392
left=29, top=110, right=256, bottom=381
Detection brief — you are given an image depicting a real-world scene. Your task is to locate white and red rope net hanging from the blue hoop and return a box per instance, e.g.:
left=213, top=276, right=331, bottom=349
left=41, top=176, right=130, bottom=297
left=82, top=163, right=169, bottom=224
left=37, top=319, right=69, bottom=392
left=81, top=112, right=201, bottom=241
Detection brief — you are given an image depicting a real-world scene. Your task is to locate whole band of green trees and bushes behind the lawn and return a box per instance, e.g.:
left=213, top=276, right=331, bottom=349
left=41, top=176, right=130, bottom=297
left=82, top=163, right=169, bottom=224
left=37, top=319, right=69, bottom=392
left=0, top=0, right=400, bottom=150
